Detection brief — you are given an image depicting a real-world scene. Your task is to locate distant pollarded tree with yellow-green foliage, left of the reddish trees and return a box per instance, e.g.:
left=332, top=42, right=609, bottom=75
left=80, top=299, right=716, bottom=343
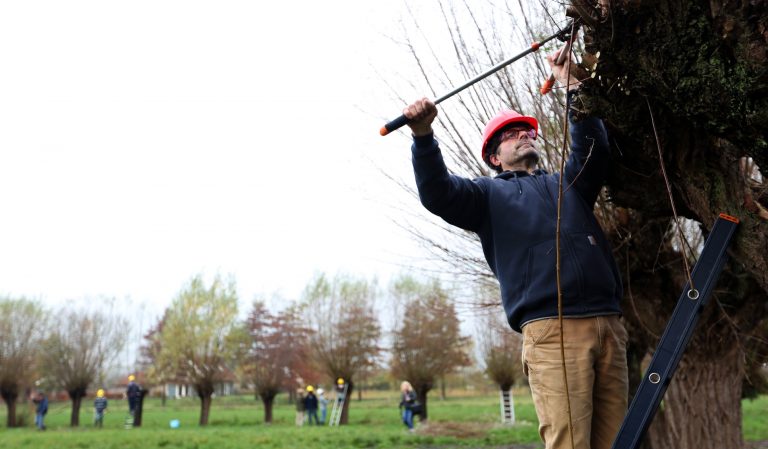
left=157, top=275, right=237, bottom=426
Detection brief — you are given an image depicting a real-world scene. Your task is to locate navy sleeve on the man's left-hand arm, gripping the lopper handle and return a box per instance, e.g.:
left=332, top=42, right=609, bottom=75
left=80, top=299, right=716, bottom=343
left=411, top=134, right=487, bottom=231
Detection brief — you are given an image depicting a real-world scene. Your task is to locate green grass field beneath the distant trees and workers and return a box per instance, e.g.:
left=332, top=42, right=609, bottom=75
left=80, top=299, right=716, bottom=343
left=0, top=389, right=768, bottom=449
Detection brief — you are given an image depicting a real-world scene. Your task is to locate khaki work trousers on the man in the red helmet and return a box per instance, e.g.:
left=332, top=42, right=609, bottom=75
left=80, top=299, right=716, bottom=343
left=522, top=315, right=628, bottom=449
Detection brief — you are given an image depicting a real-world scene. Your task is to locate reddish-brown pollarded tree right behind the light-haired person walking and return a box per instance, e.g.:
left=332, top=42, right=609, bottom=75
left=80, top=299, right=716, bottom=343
left=390, top=275, right=471, bottom=421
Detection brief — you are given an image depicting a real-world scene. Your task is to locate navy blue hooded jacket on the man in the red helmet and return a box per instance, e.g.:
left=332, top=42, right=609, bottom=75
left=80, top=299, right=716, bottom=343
left=411, top=103, right=622, bottom=332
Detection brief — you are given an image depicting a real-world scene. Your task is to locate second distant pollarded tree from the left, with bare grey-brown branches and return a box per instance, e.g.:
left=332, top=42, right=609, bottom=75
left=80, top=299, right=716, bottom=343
left=39, top=302, right=129, bottom=427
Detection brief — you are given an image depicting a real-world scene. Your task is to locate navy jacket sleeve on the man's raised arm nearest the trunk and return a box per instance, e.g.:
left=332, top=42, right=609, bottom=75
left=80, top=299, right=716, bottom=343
left=565, top=91, right=610, bottom=210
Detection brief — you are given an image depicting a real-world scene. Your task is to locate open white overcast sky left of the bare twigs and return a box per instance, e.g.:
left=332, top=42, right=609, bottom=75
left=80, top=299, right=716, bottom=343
left=0, top=0, right=452, bottom=320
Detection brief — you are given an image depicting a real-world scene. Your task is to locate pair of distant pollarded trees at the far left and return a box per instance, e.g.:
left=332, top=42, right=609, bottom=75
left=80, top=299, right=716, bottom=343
left=0, top=297, right=128, bottom=427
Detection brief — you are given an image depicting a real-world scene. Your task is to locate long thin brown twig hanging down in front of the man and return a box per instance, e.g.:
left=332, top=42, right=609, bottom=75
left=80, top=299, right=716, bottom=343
left=555, top=22, right=576, bottom=449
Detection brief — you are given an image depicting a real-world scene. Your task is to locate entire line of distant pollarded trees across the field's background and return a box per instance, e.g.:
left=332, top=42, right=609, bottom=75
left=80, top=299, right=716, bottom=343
left=0, top=274, right=536, bottom=427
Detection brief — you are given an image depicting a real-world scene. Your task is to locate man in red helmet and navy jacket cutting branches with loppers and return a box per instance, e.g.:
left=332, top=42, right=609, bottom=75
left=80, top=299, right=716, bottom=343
left=403, top=53, right=627, bottom=449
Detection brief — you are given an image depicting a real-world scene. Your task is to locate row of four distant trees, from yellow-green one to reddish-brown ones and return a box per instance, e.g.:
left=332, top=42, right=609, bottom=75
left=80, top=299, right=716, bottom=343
left=135, top=275, right=524, bottom=425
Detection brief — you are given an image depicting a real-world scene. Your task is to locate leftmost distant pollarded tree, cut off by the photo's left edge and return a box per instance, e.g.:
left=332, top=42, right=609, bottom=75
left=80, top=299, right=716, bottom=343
left=0, top=298, right=48, bottom=427
